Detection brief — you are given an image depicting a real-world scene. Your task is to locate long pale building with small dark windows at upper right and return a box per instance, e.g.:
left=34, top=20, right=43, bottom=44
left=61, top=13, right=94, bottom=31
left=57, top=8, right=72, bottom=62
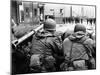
left=44, top=3, right=95, bottom=24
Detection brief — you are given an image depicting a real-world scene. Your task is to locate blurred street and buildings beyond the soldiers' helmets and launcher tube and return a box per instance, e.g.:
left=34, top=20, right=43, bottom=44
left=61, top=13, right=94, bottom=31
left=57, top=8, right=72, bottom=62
left=11, top=0, right=96, bottom=40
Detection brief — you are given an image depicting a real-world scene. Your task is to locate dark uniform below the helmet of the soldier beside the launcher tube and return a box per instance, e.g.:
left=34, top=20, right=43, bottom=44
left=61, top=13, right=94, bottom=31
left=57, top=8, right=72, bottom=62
left=30, top=32, right=63, bottom=71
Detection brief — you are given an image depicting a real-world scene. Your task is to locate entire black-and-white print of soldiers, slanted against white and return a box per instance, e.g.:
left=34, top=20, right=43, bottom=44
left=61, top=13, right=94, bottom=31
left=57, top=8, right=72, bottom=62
left=10, top=0, right=96, bottom=75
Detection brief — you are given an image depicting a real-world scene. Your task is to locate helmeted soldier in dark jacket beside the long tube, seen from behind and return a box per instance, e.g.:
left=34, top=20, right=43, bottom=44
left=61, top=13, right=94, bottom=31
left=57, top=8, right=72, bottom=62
left=30, top=19, right=63, bottom=72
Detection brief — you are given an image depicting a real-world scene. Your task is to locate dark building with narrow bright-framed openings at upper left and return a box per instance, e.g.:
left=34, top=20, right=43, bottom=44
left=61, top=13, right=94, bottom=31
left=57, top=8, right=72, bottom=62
left=11, top=0, right=44, bottom=25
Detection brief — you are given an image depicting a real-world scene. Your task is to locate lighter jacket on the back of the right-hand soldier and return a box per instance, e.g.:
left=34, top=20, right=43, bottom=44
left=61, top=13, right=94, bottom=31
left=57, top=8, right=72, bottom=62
left=63, top=31, right=93, bottom=60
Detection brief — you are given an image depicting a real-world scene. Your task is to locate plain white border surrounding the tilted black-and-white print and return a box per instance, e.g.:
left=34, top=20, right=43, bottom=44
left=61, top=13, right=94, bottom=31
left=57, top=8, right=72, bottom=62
left=0, top=0, right=100, bottom=75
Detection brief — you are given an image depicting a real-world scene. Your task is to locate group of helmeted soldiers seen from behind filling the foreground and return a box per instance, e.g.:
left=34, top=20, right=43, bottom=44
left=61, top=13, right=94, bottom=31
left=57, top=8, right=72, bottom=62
left=12, top=19, right=96, bottom=73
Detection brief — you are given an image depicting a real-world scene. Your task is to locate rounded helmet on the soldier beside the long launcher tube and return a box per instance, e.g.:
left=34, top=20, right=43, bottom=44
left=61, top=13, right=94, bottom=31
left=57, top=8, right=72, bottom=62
left=43, top=19, right=56, bottom=31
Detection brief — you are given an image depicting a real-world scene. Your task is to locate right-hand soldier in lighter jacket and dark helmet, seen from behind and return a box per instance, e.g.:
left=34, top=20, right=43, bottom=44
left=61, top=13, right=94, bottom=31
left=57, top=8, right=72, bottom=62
left=61, top=25, right=95, bottom=70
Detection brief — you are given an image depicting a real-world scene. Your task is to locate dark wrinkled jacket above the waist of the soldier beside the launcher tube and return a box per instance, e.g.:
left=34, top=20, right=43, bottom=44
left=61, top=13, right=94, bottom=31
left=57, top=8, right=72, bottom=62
left=31, top=31, right=63, bottom=56
